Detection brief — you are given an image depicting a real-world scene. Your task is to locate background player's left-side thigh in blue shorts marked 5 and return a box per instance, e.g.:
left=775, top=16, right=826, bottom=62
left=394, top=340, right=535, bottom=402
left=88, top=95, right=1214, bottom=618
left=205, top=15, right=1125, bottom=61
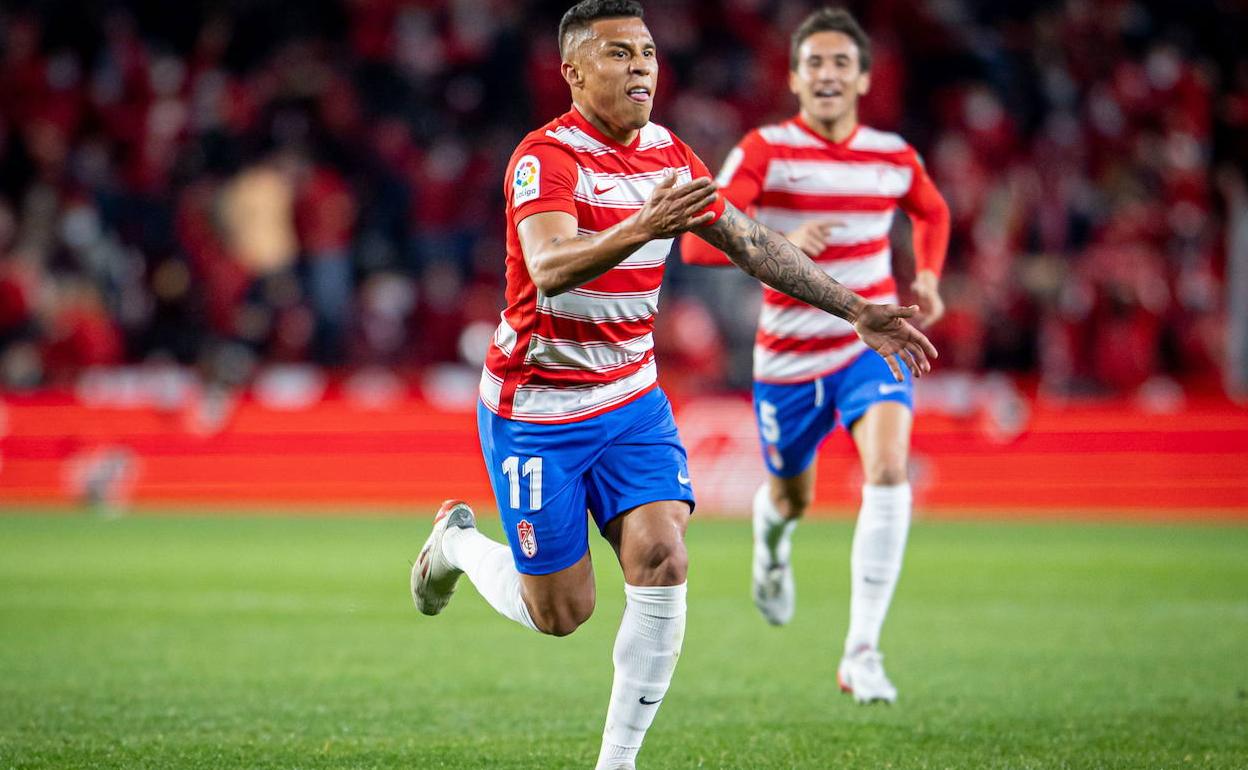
left=754, top=378, right=836, bottom=478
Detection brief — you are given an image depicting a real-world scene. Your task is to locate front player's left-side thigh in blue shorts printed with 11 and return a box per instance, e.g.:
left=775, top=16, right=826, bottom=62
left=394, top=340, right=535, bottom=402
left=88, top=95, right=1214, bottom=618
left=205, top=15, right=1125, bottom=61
left=477, top=404, right=602, bottom=575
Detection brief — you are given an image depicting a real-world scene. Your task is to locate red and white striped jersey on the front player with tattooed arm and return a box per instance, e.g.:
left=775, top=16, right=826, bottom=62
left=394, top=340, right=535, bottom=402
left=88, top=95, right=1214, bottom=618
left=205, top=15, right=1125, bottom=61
left=480, top=109, right=724, bottom=423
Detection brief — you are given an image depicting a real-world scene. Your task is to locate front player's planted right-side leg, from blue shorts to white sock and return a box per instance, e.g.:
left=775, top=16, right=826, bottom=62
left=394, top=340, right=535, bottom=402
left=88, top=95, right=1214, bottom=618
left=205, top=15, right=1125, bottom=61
left=588, top=391, right=693, bottom=768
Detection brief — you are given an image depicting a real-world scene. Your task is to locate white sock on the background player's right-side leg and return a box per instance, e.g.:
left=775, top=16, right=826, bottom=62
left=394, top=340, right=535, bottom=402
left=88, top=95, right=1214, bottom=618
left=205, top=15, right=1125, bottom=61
left=845, top=484, right=911, bottom=654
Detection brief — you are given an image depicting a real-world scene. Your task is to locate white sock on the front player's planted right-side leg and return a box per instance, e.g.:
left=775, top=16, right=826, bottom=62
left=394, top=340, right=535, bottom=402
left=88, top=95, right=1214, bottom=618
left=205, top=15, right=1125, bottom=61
left=597, top=583, right=686, bottom=770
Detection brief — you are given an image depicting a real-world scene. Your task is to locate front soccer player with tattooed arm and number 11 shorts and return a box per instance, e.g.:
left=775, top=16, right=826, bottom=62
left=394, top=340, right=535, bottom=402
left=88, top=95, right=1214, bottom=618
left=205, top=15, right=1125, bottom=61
left=412, top=0, right=936, bottom=768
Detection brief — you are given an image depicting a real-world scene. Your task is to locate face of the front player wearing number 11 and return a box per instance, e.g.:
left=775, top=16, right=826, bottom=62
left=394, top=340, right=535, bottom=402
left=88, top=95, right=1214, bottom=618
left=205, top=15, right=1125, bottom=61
left=564, top=19, right=659, bottom=132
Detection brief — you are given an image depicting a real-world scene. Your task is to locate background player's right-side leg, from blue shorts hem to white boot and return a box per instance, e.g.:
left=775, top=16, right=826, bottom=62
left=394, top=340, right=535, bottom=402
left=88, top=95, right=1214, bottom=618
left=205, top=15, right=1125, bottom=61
left=837, top=353, right=912, bottom=703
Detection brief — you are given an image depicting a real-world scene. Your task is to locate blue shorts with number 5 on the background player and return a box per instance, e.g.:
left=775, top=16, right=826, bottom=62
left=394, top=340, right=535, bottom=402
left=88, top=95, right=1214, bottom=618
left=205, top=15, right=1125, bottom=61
left=754, top=351, right=914, bottom=478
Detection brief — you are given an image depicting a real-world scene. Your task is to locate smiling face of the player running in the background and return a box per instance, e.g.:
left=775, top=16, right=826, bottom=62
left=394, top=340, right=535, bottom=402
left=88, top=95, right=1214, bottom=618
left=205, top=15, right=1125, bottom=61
left=789, top=31, right=871, bottom=122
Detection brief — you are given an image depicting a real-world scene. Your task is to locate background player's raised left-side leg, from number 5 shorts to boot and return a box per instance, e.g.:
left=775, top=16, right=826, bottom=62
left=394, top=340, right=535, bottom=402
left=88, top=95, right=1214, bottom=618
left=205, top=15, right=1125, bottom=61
left=751, top=379, right=835, bottom=625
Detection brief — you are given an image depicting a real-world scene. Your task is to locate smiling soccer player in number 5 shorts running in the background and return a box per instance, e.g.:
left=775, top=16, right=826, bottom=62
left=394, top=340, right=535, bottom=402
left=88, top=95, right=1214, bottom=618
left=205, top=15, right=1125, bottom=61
left=681, top=9, right=948, bottom=703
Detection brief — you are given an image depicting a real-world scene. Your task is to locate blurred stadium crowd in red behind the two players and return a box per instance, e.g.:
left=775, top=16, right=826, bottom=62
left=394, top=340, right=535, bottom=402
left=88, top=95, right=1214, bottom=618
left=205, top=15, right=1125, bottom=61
left=0, top=0, right=1248, bottom=393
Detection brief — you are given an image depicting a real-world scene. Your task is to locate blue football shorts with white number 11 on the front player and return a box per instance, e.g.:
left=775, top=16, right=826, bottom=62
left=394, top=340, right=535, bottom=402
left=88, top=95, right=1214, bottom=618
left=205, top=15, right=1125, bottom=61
left=477, top=388, right=694, bottom=575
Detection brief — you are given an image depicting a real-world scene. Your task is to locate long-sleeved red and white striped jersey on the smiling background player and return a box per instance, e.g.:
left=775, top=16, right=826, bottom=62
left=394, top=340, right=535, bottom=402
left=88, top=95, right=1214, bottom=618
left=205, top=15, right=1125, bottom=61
left=681, top=116, right=948, bottom=383
